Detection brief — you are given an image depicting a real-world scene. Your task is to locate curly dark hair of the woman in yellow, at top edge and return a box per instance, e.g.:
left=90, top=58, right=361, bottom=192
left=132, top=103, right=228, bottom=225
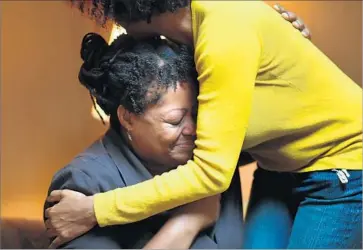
left=71, top=0, right=191, bottom=24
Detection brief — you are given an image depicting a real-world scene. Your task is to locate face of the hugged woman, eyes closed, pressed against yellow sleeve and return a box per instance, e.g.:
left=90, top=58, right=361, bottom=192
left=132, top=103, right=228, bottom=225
left=121, top=82, right=197, bottom=173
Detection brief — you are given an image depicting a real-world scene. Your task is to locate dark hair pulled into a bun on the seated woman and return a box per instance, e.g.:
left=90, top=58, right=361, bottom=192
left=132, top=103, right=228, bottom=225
left=78, top=33, right=197, bottom=126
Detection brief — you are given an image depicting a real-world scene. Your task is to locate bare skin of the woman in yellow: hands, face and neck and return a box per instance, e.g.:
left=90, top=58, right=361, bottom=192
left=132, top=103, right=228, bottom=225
left=45, top=5, right=311, bottom=247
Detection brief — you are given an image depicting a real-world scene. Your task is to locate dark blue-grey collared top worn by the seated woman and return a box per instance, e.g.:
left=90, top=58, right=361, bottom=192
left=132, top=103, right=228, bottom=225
left=45, top=129, right=243, bottom=249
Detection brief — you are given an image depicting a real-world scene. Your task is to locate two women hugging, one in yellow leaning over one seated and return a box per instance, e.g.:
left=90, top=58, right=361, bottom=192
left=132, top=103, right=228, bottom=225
left=44, top=0, right=362, bottom=249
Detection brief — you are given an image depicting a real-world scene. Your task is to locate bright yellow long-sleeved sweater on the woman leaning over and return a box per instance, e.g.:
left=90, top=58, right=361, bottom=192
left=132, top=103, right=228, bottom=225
left=94, top=1, right=362, bottom=226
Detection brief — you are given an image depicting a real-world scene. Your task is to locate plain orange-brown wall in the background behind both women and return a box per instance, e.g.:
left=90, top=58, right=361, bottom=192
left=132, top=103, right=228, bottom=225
left=1, top=1, right=362, bottom=221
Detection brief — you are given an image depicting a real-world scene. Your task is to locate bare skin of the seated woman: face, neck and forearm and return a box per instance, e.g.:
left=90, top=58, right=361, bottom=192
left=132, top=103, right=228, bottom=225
left=46, top=82, right=220, bottom=249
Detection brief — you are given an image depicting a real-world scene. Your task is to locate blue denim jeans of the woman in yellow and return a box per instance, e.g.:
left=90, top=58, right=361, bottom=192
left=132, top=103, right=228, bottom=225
left=243, top=168, right=362, bottom=249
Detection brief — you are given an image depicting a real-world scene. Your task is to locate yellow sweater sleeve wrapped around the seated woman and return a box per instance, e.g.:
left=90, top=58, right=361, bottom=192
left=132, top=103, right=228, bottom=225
left=94, top=4, right=261, bottom=226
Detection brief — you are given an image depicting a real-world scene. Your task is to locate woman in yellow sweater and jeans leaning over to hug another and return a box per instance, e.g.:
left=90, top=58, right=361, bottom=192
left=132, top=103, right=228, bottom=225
left=46, top=0, right=362, bottom=248
